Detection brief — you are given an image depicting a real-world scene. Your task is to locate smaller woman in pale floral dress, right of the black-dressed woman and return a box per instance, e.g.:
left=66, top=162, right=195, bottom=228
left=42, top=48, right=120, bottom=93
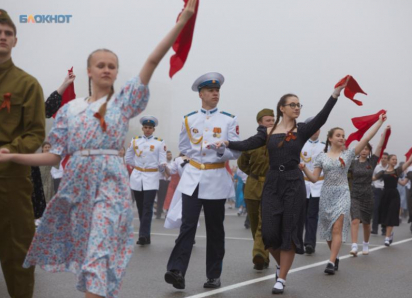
left=301, top=115, right=386, bottom=274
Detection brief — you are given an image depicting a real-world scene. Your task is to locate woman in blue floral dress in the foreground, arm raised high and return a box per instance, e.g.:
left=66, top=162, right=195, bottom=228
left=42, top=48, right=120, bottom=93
left=0, top=0, right=196, bottom=298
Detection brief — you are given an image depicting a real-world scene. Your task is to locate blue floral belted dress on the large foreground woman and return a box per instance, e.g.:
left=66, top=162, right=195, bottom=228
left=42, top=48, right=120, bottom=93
left=24, top=77, right=149, bottom=298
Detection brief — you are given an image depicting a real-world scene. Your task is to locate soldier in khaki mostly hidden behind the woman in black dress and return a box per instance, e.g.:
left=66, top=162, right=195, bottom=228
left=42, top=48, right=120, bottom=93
left=237, top=109, right=275, bottom=270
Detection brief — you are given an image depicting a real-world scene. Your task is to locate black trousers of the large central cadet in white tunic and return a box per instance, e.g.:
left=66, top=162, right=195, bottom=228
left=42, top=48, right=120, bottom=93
left=167, top=187, right=226, bottom=278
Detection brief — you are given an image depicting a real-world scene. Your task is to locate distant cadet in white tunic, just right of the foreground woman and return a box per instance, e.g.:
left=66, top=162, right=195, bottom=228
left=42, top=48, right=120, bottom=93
left=125, top=116, right=167, bottom=245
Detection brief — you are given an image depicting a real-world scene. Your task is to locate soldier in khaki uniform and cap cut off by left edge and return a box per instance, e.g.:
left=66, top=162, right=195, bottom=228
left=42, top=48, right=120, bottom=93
left=0, top=9, right=45, bottom=298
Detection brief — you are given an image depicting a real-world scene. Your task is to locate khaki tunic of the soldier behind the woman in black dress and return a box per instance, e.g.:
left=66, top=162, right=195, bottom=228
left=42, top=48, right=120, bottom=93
left=237, top=146, right=269, bottom=201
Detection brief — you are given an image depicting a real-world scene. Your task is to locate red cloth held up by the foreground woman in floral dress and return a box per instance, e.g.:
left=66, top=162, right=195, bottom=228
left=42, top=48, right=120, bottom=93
left=169, top=0, right=199, bottom=78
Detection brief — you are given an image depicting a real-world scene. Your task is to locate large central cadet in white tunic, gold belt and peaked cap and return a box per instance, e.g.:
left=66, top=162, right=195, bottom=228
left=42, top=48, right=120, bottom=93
left=165, top=73, right=240, bottom=289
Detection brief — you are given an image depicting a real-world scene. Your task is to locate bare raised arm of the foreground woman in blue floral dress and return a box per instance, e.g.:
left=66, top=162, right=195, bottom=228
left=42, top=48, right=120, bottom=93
left=140, top=0, right=197, bottom=85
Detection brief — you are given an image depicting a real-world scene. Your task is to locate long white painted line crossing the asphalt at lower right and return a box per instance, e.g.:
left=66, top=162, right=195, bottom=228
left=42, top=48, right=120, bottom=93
left=186, top=238, right=412, bottom=298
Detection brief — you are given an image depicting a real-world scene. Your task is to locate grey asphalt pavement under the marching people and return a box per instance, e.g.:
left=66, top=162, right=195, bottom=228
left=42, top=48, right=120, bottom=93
left=0, top=210, right=412, bottom=298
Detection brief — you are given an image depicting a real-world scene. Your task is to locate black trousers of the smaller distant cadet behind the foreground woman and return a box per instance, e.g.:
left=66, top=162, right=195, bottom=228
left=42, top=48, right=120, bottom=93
left=133, top=189, right=157, bottom=237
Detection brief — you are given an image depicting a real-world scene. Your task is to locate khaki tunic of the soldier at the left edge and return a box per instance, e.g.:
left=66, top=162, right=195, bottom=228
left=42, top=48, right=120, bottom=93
left=0, top=59, right=45, bottom=177
